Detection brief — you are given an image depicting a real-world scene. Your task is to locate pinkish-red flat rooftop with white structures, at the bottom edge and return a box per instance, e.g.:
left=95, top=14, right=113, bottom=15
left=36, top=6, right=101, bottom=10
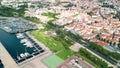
left=57, top=56, right=93, bottom=68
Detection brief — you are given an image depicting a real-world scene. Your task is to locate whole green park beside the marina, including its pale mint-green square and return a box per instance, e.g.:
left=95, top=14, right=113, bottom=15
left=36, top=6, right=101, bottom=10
left=30, top=30, right=77, bottom=68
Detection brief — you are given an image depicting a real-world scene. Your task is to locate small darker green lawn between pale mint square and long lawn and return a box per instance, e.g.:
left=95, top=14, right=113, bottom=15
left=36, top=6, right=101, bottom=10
left=56, top=49, right=74, bottom=60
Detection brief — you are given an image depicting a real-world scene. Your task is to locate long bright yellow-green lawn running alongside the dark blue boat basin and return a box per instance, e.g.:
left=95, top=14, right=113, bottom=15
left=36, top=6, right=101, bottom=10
left=30, top=30, right=64, bottom=52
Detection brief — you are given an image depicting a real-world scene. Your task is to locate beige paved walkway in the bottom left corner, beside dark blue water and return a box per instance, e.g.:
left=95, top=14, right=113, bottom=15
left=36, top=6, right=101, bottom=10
left=0, top=43, right=18, bottom=68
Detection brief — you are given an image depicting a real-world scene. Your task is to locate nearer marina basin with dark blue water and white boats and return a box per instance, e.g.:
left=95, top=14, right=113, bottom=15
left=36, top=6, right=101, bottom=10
left=0, top=30, right=44, bottom=63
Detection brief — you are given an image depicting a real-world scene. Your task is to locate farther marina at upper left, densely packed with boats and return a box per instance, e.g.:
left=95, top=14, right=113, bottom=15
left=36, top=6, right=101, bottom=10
left=0, top=17, right=37, bottom=33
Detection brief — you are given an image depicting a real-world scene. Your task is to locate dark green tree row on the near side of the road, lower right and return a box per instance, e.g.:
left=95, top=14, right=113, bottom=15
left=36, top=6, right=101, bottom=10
left=79, top=48, right=108, bottom=68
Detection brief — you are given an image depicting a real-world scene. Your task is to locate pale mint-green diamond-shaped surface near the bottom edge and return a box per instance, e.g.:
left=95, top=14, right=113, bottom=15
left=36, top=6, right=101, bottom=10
left=43, top=55, right=64, bottom=68
